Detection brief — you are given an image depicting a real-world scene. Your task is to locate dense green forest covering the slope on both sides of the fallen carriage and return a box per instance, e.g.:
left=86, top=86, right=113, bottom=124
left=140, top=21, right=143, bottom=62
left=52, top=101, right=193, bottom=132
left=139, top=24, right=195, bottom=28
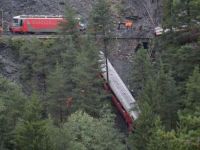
left=0, top=0, right=200, bottom=150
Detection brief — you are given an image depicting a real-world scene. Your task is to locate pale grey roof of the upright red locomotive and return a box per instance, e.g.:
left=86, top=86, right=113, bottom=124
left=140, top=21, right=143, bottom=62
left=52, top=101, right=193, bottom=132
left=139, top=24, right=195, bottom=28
left=13, top=15, right=63, bottom=19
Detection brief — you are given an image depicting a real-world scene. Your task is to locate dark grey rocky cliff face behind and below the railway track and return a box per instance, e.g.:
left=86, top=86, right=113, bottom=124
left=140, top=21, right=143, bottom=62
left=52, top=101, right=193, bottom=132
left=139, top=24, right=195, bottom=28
left=0, top=0, right=162, bottom=83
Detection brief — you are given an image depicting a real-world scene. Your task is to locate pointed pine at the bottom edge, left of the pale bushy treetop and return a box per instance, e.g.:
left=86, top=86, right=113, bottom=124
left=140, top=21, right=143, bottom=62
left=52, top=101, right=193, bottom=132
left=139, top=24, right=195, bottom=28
left=14, top=95, right=51, bottom=150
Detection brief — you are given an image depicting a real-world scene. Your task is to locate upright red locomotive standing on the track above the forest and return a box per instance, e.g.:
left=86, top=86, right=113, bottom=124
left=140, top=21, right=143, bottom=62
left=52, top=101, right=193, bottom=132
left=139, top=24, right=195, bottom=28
left=9, top=15, right=84, bottom=33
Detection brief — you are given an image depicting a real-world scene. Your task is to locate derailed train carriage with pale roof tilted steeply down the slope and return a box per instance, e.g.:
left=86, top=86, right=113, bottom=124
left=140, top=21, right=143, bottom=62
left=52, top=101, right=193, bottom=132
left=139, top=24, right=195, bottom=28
left=99, top=51, right=140, bottom=131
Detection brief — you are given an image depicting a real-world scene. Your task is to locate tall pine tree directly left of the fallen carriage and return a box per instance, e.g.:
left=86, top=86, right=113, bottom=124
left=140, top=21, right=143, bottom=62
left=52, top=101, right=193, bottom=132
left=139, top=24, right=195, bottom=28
left=72, top=39, right=106, bottom=116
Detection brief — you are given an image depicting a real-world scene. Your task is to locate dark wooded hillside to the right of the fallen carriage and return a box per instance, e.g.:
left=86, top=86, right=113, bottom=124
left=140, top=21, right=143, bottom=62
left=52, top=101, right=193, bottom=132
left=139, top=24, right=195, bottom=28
left=129, top=0, right=200, bottom=150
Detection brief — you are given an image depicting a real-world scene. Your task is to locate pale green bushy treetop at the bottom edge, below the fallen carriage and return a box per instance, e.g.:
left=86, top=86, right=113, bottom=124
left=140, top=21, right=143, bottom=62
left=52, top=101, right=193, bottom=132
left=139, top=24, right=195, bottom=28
left=63, top=112, right=125, bottom=150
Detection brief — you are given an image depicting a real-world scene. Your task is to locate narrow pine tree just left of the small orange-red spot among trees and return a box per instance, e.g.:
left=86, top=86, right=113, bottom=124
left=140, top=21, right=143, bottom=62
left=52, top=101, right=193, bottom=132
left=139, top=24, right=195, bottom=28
left=46, top=63, right=69, bottom=122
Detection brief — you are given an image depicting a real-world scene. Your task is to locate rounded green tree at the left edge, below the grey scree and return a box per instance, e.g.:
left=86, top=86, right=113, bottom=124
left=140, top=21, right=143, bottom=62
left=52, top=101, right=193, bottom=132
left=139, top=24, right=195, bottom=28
left=0, top=76, right=26, bottom=149
